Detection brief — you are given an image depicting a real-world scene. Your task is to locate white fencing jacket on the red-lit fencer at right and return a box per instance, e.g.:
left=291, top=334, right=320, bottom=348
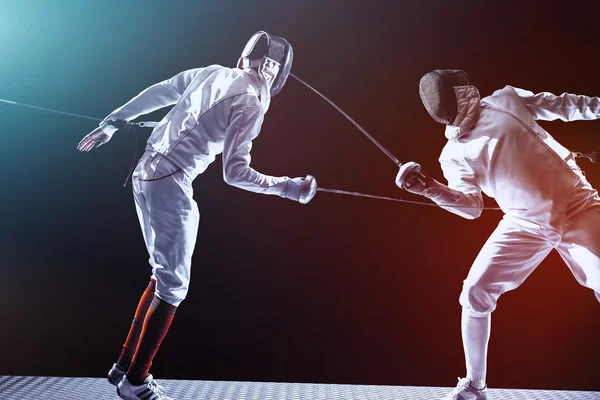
left=439, top=86, right=600, bottom=229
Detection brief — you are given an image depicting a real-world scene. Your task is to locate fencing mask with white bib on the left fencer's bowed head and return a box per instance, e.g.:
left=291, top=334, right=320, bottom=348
left=238, top=31, right=294, bottom=96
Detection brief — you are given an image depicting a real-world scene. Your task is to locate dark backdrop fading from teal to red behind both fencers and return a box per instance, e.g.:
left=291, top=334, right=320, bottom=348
left=0, top=0, right=600, bottom=390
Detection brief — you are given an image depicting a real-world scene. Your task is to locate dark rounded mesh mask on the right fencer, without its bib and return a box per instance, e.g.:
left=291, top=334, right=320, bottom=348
left=419, top=69, right=472, bottom=125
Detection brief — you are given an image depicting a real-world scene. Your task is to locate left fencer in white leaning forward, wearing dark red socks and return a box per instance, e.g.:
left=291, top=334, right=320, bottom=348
left=78, top=31, right=316, bottom=400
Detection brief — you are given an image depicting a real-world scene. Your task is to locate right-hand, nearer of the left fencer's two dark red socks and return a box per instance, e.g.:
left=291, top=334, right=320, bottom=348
left=127, top=296, right=177, bottom=385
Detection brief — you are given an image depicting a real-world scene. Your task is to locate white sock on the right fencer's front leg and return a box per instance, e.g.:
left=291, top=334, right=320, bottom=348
left=462, top=308, right=492, bottom=389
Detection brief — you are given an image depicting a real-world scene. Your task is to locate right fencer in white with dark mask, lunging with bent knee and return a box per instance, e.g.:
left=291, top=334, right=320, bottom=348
left=397, top=70, right=600, bottom=400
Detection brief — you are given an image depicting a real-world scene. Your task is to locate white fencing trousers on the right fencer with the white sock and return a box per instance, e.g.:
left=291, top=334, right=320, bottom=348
left=460, top=178, right=600, bottom=317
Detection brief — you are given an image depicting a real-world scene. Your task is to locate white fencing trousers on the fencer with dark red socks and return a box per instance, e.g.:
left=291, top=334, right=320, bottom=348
left=132, top=151, right=200, bottom=306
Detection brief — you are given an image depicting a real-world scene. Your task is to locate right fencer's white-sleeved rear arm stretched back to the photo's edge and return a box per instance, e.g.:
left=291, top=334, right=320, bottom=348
left=513, top=88, right=600, bottom=122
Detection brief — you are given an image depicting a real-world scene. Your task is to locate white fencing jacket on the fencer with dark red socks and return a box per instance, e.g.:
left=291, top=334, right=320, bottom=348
left=100, top=65, right=290, bottom=195
